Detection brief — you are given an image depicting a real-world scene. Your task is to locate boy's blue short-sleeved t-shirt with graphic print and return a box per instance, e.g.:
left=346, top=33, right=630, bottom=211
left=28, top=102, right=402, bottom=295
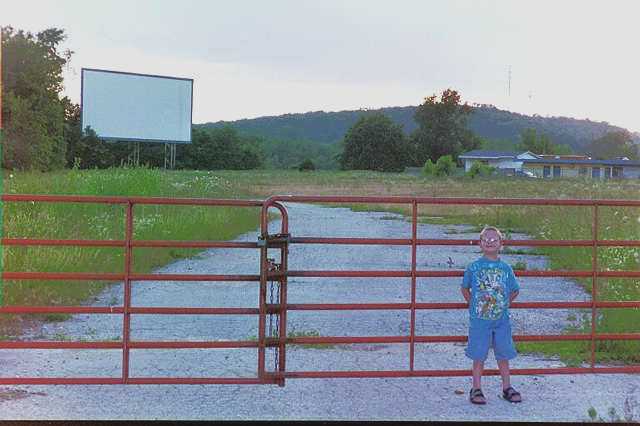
left=462, top=256, right=520, bottom=323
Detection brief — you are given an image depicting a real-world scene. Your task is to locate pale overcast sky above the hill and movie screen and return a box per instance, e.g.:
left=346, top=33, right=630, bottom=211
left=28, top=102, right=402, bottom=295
left=5, top=0, right=640, bottom=131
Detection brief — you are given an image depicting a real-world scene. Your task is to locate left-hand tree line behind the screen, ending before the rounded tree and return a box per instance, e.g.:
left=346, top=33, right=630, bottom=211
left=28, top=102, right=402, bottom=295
left=0, top=26, right=337, bottom=171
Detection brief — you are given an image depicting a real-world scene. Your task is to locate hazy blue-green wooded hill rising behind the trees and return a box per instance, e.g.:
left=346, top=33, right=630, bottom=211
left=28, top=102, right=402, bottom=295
left=196, top=105, right=640, bottom=153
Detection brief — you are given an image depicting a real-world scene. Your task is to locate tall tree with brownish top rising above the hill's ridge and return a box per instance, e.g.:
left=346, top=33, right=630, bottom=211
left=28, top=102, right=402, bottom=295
left=411, top=89, right=481, bottom=164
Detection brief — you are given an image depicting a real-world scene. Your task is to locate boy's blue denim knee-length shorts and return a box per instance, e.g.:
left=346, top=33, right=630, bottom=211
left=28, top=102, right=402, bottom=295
left=465, top=318, right=518, bottom=361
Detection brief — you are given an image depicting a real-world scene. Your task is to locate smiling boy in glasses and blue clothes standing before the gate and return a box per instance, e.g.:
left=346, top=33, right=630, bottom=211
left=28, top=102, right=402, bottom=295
left=461, top=226, right=522, bottom=404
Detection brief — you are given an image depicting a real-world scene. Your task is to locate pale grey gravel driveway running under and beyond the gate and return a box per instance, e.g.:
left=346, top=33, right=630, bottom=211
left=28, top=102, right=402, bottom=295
left=0, top=204, right=640, bottom=421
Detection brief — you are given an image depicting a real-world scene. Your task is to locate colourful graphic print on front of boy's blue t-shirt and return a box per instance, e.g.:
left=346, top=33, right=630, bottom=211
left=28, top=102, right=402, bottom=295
left=476, top=268, right=506, bottom=320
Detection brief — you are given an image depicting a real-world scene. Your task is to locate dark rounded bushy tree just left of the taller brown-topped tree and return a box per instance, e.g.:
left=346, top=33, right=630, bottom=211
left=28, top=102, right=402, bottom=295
left=340, top=113, right=407, bottom=172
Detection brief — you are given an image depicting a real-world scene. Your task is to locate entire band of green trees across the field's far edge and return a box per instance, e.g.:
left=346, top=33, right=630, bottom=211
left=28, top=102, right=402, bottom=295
left=1, top=26, right=638, bottom=171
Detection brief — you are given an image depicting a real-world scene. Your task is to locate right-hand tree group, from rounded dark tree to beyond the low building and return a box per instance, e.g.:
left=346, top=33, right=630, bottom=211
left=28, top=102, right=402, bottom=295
left=340, top=89, right=640, bottom=175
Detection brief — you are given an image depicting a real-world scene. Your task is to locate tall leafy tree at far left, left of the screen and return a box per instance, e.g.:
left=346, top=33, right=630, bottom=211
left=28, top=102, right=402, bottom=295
left=1, top=27, right=72, bottom=171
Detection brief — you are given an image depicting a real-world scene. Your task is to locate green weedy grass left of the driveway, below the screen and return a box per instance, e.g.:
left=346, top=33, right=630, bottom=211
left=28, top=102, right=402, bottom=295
left=3, top=168, right=259, bottom=323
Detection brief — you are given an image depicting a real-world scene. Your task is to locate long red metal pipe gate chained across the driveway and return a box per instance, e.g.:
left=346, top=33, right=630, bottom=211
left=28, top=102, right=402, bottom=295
left=0, top=195, right=640, bottom=386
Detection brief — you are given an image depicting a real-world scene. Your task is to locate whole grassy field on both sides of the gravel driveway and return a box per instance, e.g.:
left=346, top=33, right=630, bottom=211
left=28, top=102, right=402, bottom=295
left=3, top=168, right=640, bottom=364
